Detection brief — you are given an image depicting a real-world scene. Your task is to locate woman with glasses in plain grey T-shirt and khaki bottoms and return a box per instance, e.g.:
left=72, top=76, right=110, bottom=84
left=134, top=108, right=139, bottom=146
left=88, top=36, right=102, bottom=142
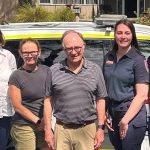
left=9, top=38, right=50, bottom=150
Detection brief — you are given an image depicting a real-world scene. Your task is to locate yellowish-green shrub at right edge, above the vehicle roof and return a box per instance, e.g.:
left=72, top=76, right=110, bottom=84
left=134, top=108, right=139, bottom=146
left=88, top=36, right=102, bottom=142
left=136, top=8, right=150, bottom=26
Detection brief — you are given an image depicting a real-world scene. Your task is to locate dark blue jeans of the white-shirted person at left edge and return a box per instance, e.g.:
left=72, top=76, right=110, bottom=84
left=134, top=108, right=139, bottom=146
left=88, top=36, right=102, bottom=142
left=0, top=117, right=11, bottom=150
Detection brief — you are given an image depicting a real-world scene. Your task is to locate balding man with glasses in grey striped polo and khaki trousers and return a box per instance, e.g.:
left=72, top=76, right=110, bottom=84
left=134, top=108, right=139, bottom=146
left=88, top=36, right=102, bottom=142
left=44, top=30, right=107, bottom=150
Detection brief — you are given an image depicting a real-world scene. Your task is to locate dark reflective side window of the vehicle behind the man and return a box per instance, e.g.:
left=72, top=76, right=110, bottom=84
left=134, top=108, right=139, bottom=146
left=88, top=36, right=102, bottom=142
left=4, top=39, right=110, bottom=67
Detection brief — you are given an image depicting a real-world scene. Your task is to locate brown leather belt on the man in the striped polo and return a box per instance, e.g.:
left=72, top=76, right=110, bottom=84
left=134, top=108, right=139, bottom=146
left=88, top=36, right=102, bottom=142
left=56, top=120, right=95, bottom=128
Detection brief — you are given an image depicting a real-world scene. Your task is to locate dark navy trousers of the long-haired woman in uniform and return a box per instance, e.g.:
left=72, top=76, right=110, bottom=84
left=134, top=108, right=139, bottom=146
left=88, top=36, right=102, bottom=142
left=108, top=102, right=146, bottom=150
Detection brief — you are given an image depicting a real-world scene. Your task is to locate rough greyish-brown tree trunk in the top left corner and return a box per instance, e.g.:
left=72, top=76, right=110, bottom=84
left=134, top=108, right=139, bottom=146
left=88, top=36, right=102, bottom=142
left=0, top=0, right=18, bottom=23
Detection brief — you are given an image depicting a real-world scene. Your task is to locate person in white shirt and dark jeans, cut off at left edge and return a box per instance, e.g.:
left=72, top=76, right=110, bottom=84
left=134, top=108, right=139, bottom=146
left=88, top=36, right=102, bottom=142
left=0, top=31, right=16, bottom=150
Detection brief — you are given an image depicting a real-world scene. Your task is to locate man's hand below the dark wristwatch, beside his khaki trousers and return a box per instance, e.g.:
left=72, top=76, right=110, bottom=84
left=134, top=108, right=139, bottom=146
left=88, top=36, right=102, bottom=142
left=94, top=129, right=104, bottom=149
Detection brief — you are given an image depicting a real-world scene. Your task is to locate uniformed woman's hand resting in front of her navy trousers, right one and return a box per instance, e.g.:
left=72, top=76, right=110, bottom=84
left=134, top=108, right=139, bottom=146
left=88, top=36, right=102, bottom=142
left=119, top=119, right=128, bottom=140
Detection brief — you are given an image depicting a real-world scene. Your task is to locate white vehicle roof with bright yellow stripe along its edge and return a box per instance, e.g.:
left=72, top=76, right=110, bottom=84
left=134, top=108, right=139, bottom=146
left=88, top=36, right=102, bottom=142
left=0, top=22, right=150, bottom=40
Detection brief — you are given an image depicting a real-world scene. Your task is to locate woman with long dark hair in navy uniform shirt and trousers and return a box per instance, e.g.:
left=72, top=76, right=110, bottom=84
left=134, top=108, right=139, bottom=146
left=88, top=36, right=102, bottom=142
left=104, top=19, right=149, bottom=150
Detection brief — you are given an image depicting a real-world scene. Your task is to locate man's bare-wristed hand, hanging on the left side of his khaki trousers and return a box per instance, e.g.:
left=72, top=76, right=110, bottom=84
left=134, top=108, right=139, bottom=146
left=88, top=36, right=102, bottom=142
left=45, top=129, right=55, bottom=150
